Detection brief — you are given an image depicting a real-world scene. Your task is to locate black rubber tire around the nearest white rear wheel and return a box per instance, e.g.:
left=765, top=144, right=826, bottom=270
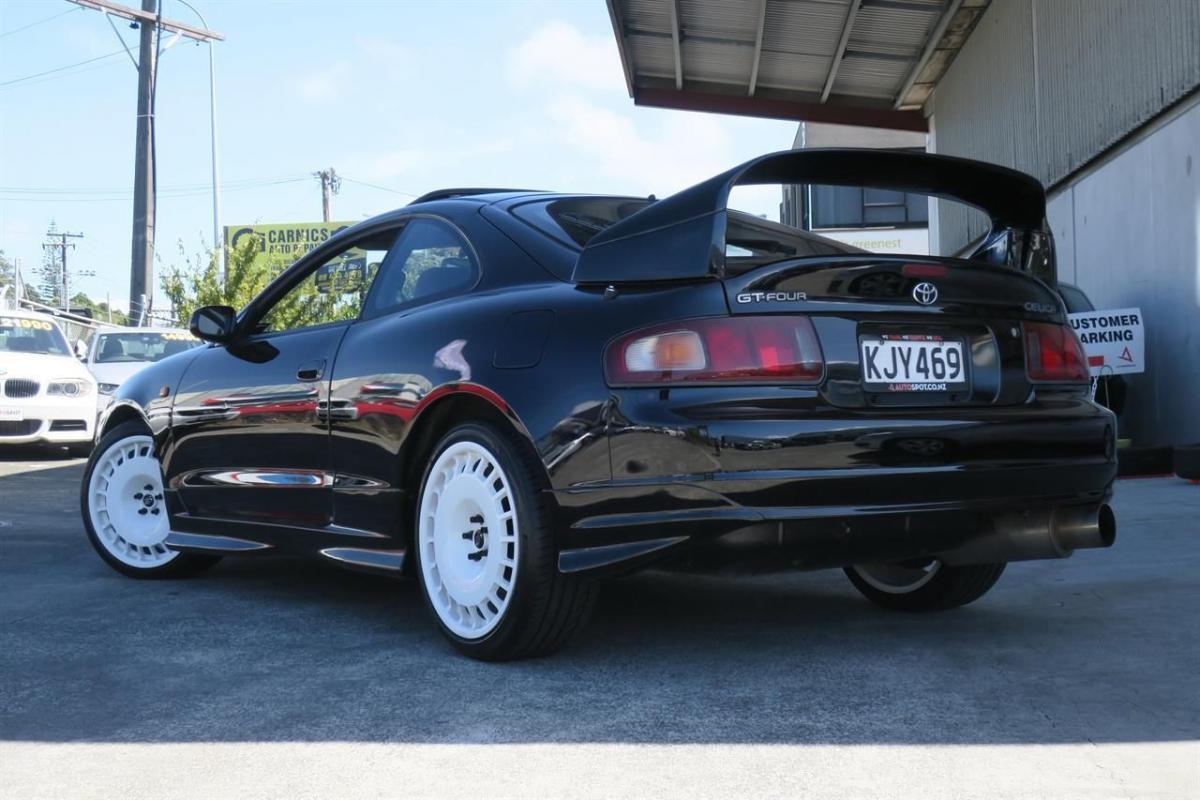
left=413, top=422, right=596, bottom=661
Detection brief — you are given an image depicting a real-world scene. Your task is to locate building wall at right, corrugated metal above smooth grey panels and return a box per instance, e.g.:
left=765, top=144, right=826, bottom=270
left=932, top=0, right=1200, bottom=444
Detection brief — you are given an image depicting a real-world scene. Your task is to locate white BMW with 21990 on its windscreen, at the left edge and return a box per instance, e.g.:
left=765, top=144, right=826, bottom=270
left=0, top=311, right=96, bottom=456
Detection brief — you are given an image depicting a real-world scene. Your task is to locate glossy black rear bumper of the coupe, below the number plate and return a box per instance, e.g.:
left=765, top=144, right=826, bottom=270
left=554, top=398, right=1116, bottom=572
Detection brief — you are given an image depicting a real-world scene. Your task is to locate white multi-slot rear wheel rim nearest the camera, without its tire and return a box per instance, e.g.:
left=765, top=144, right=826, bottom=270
left=416, top=439, right=520, bottom=639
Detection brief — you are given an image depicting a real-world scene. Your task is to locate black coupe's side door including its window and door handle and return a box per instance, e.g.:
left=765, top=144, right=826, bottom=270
left=164, top=225, right=396, bottom=534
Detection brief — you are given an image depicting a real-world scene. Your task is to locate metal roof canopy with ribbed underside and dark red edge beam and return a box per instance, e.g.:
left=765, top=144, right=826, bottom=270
left=607, top=0, right=991, bottom=132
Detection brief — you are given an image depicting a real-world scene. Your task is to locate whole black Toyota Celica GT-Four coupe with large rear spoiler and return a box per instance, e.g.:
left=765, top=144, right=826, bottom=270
left=82, top=150, right=1116, bottom=660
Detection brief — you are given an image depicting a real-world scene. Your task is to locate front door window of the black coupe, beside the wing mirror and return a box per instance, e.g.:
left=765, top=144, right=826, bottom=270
left=257, top=230, right=396, bottom=333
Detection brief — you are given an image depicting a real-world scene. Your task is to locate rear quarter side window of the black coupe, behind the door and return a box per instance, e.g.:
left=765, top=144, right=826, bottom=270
left=364, top=218, right=479, bottom=317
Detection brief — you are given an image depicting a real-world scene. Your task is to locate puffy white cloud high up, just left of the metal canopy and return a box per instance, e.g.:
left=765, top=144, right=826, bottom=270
left=508, top=22, right=625, bottom=90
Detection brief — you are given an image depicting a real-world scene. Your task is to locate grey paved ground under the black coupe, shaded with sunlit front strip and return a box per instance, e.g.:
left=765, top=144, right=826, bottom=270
left=0, top=453, right=1200, bottom=800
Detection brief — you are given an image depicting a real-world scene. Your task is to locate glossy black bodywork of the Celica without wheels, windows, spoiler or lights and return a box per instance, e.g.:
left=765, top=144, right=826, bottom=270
left=102, top=159, right=1116, bottom=571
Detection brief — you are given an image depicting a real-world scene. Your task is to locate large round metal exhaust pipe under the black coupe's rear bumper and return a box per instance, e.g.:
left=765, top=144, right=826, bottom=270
left=936, top=503, right=1117, bottom=566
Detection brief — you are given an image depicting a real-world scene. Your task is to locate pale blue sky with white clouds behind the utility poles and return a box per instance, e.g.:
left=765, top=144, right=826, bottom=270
left=0, top=0, right=796, bottom=306
